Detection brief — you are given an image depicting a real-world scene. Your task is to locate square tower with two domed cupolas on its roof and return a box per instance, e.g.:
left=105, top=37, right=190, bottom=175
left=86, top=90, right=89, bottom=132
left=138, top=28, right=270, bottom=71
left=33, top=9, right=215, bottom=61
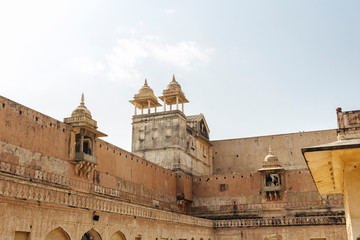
left=130, top=77, right=212, bottom=175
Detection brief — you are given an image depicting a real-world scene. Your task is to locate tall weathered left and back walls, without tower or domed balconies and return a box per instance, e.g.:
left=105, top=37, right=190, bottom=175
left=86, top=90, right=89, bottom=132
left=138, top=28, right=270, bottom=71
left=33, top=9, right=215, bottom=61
left=0, top=94, right=345, bottom=240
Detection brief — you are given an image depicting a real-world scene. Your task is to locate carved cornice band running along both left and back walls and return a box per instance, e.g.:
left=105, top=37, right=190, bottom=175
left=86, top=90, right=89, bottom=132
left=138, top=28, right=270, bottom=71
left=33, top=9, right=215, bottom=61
left=0, top=162, right=345, bottom=228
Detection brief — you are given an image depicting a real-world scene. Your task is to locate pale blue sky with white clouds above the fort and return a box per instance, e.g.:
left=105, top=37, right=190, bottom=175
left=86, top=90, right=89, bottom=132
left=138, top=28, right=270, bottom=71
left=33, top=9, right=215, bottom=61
left=0, top=0, right=360, bottom=151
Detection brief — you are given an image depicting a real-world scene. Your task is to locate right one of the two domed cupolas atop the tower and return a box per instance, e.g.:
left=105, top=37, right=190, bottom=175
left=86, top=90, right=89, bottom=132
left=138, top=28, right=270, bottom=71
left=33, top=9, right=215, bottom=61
left=159, top=75, right=189, bottom=112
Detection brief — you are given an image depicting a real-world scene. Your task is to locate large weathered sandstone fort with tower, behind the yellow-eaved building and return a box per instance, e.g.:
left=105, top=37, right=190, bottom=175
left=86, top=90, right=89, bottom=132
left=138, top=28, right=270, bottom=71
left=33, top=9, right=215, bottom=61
left=0, top=77, right=347, bottom=240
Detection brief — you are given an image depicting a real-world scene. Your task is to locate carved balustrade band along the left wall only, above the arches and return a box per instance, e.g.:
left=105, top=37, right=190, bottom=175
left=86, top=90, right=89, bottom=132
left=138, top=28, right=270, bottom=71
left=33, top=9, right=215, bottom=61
left=0, top=174, right=213, bottom=227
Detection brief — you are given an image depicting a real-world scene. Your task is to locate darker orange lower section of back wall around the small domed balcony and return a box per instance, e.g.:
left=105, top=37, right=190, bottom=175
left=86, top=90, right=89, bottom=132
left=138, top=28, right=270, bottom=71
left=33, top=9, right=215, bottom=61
left=192, top=170, right=343, bottom=218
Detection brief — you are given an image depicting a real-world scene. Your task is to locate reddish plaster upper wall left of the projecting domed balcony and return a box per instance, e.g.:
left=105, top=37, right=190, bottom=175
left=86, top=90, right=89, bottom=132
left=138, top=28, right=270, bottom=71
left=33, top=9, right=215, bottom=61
left=0, top=96, right=72, bottom=161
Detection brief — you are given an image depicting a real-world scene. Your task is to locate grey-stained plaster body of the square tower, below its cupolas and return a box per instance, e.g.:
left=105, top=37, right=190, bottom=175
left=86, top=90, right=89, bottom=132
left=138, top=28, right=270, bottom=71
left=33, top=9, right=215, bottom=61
left=132, top=111, right=212, bottom=175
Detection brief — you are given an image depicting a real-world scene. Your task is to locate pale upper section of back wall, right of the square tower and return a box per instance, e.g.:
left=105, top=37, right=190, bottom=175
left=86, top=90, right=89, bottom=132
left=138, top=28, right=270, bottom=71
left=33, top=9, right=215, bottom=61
left=211, top=130, right=337, bottom=174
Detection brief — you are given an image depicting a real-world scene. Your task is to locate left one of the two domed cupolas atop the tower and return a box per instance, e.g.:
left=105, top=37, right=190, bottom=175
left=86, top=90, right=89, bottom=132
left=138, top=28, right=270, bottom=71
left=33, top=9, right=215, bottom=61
left=130, top=79, right=161, bottom=115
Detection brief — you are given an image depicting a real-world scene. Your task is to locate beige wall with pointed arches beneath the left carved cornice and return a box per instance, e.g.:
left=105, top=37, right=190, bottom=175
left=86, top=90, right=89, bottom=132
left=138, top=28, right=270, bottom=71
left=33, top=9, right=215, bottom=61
left=0, top=199, right=214, bottom=240
